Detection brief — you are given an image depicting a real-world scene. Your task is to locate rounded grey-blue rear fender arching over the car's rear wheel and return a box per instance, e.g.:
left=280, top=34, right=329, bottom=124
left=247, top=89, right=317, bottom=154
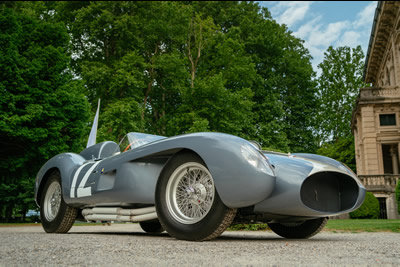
left=35, top=153, right=85, bottom=206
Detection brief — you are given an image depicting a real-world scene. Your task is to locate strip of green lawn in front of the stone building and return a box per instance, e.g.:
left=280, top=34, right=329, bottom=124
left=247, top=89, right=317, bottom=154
left=324, top=220, right=400, bottom=233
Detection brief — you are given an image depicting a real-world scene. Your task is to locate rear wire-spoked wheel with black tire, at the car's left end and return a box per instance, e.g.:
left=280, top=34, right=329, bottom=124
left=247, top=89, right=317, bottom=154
left=40, top=172, right=78, bottom=233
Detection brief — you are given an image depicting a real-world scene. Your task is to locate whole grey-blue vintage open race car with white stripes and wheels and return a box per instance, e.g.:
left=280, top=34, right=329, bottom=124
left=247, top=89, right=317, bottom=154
left=35, top=133, right=365, bottom=241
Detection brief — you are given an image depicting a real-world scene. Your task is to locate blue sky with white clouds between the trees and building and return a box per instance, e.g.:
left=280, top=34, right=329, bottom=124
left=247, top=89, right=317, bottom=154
left=259, top=1, right=377, bottom=74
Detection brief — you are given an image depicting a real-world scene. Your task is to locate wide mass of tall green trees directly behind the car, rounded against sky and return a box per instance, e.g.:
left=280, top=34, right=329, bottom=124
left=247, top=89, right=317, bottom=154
left=55, top=1, right=316, bottom=152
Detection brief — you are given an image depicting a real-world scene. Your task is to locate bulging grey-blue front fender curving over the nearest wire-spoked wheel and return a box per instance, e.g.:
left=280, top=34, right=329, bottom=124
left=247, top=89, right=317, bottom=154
left=159, top=133, right=275, bottom=208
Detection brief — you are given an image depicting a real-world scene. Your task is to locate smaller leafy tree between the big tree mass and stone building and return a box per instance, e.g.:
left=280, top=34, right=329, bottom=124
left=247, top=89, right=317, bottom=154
left=315, top=46, right=364, bottom=172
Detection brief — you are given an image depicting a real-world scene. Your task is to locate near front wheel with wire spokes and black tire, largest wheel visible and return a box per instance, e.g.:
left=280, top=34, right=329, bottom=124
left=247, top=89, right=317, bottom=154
left=156, top=153, right=236, bottom=241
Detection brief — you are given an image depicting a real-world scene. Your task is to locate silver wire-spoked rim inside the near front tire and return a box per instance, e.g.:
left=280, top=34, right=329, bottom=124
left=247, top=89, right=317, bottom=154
left=166, top=162, right=215, bottom=224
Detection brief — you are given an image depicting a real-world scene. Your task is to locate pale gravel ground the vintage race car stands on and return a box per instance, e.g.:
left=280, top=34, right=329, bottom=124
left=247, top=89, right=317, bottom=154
left=0, top=224, right=400, bottom=266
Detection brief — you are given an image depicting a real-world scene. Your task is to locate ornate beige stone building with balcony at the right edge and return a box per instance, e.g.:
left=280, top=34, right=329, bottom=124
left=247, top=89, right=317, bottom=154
left=352, top=1, right=400, bottom=219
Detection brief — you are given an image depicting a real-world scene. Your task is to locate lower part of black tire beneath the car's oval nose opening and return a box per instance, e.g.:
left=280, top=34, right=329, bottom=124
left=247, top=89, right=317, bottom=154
left=268, top=218, right=328, bottom=239
